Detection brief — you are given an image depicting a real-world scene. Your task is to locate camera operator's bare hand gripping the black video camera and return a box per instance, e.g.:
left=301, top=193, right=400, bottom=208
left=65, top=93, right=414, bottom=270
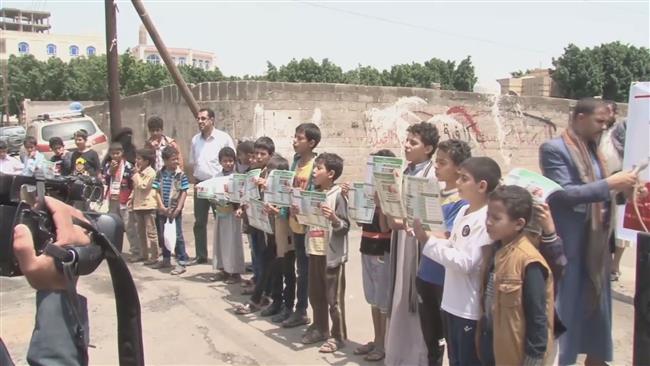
left=14, top=197, right=90, bottom=290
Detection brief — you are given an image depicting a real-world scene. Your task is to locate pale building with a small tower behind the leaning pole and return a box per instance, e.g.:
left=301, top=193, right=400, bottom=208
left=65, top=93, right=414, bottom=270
left=131, top=26, right=217, bottom=70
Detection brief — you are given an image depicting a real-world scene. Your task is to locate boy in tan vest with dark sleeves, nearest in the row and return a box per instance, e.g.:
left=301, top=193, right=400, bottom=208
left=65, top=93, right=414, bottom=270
left=479, top=186, right=554, bottom=366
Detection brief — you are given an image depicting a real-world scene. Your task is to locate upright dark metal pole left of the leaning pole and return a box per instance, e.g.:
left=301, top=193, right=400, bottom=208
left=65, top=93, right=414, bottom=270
left=104, top=0, right=122, bottom=136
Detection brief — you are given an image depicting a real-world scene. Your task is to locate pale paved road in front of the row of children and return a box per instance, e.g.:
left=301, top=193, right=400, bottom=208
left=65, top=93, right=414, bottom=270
left=0, top=194, right=634, bottom=365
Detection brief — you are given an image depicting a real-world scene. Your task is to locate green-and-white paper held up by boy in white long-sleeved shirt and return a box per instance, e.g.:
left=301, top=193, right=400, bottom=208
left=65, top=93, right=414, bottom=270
left=404, top=176, right=446, bottom=232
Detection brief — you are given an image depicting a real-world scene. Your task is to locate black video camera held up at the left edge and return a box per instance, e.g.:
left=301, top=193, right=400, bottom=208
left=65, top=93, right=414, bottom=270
left=0, top=174, right=124, bottom=276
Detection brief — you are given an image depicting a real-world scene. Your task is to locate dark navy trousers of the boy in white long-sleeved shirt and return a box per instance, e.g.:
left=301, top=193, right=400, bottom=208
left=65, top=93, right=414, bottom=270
left=444, top=313, right=481, bottom=366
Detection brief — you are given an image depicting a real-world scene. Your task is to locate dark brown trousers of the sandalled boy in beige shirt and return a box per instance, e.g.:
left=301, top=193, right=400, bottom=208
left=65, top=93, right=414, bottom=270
left=309, top=255, right=347, bottom=340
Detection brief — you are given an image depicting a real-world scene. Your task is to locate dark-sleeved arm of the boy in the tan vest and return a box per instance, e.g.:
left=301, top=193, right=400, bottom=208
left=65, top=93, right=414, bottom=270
left=522, top=263, right=548, bottom=366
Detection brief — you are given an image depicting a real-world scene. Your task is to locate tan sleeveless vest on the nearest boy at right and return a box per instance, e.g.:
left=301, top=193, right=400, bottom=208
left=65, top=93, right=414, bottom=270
left=491, top=236, right=554, bottom=365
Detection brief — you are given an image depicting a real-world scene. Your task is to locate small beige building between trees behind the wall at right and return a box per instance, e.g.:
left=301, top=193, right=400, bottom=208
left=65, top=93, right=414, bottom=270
left=497, top=69, right=560, bottom=97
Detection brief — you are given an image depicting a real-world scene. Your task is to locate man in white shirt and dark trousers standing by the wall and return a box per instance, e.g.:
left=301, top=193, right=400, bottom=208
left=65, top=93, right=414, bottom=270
left=189, top=108, right=235, bottom=265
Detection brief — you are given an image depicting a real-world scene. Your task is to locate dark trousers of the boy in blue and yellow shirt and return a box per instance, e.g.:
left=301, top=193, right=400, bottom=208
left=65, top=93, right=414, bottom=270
left=415, top=278, right=445, bottom=366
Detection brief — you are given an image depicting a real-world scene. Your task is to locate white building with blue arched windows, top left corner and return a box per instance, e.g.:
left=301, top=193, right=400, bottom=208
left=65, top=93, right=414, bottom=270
left=0, top=8, right=106, bottom=62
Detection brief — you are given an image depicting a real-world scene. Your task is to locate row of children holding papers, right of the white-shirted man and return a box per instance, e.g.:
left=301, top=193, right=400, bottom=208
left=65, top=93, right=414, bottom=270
left=206, top=122, right=566, bottom=365
